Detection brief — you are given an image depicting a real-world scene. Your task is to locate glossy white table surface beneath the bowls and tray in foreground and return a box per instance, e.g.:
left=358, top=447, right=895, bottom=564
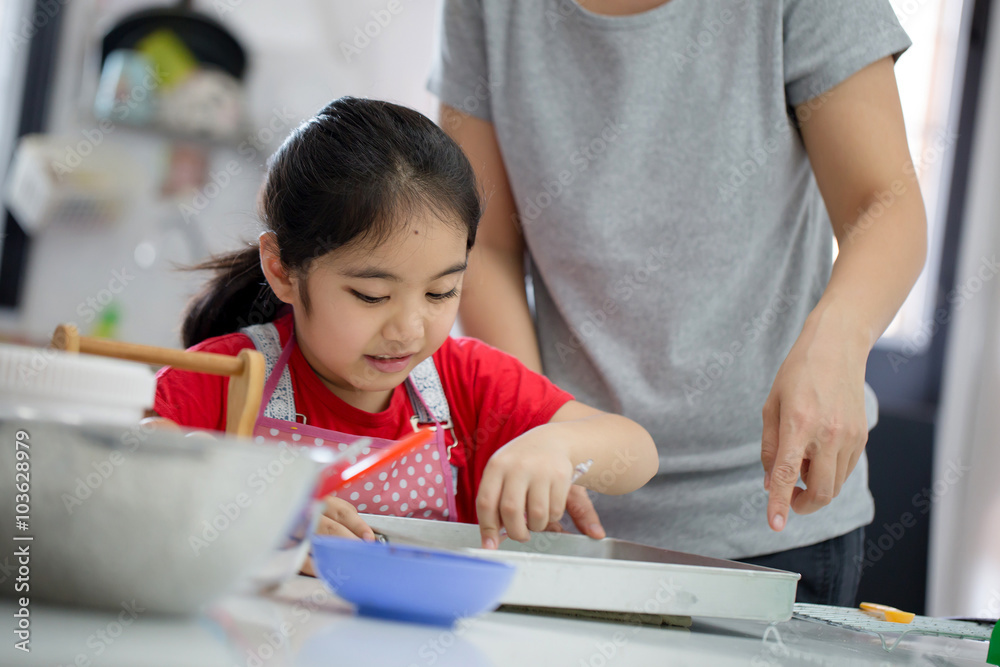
left=0, top=576, right=987, bottom=667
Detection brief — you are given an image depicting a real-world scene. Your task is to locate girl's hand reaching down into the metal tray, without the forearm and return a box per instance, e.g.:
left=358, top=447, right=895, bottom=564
left=476, top=430, right=573, bottom=549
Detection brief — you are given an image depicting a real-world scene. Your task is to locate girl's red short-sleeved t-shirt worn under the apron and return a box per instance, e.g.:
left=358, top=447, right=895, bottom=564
left=154, top=314, right=573, bottom=523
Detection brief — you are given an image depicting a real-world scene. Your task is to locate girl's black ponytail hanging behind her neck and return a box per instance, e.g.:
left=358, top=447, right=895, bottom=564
left=181, top=244, right=284, bottom=347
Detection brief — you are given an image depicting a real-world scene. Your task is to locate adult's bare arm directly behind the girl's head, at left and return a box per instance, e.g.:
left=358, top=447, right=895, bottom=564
left=440, top=105, right=542, bottom=373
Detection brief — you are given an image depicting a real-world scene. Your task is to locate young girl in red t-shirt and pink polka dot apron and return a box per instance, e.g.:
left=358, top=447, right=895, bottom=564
left=155, top=97, right=658, bottom=548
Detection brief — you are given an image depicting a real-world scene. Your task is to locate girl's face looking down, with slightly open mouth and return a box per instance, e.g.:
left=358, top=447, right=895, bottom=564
left=279, top=211, right=468, bottom=412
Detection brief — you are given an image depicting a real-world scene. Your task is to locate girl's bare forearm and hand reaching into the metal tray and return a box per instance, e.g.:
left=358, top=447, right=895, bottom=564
left=476, top=401, right=659, bottom=549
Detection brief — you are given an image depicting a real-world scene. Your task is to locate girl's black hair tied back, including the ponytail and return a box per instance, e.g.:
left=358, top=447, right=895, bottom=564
left=181, top=97, right=482, bottom=347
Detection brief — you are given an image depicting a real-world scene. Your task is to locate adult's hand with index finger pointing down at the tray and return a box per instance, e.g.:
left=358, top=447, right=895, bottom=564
left=761, top=318, right=868, bottom=531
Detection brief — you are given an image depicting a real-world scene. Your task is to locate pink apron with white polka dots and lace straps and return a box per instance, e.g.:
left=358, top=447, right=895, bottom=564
left=240, top=322, right=457, bottom=521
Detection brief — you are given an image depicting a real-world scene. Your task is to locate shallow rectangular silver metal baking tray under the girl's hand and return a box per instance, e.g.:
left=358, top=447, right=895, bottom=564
left=362, top=514, right=799, bottom=621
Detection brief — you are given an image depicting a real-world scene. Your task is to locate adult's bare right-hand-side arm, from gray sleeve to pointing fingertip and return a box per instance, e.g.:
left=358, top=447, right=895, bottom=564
left=761, top=58, right=927, bottom=530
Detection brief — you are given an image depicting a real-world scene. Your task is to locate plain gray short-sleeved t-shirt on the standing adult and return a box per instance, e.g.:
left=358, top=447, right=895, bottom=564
left=428, top=0, right=910, bottom=558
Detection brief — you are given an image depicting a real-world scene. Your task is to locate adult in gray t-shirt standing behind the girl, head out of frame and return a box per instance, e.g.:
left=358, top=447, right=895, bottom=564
left=429, top=0, right=926, bottom=605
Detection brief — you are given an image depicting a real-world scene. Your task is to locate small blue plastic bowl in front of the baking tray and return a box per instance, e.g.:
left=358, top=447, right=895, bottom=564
left=312, top=535, right=516, bottom=626
